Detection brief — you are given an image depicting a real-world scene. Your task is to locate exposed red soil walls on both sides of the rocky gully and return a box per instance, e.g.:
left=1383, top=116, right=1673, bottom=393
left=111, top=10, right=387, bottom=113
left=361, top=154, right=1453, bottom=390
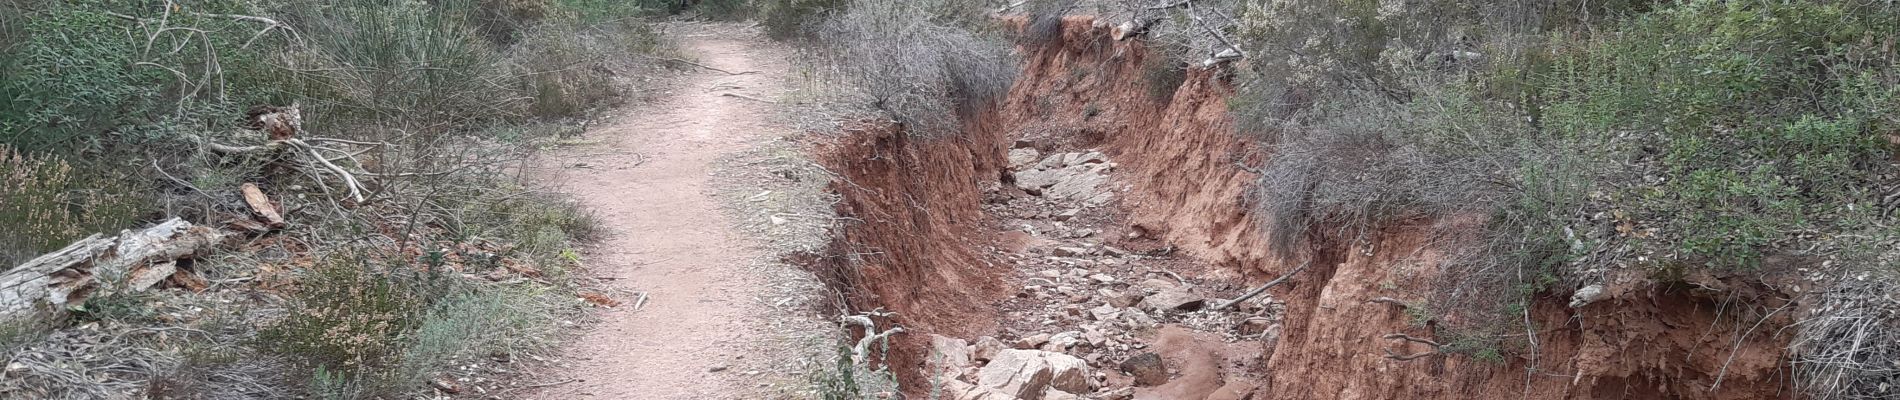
left=809, top=17, right=1797, bottom=398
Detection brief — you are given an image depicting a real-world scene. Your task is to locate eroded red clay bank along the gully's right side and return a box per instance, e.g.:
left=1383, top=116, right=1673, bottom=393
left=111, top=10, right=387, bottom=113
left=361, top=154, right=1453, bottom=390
left=1001, top=17, right=1796, bottom=398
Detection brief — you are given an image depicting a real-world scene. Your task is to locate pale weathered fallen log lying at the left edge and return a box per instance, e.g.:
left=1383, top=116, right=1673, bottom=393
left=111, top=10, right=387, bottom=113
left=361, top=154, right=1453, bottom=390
left=0, top=218, right=224, bottom=320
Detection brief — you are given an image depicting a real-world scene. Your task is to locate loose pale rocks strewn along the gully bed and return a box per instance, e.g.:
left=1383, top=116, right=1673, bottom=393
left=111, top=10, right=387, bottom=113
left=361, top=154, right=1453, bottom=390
left=927, top=148, right=1281, bottom=400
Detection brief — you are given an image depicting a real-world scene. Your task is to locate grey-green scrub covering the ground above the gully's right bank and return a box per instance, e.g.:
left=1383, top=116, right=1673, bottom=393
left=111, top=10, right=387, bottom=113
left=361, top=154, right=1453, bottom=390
left=1124, top=0, right=1900, bottom=398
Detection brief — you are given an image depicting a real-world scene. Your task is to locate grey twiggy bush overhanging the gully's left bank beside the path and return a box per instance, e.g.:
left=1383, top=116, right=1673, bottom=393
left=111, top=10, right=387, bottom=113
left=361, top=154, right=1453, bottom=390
left=819, top=0, right=1017, bottom=135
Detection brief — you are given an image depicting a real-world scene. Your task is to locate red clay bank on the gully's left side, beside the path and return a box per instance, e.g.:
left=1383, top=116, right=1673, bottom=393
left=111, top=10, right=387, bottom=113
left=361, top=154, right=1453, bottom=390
left=800, top=116, right=1007, bottom=385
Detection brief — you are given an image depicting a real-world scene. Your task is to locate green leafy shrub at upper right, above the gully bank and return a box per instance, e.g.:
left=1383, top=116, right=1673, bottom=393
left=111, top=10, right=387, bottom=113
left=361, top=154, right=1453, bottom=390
left=1545, top=2, right=1900, bottom=267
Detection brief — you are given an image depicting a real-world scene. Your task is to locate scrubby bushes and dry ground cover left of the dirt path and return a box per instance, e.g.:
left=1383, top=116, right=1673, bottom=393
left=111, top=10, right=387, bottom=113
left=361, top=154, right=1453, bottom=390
left=0, top=0, right=684, bottom=398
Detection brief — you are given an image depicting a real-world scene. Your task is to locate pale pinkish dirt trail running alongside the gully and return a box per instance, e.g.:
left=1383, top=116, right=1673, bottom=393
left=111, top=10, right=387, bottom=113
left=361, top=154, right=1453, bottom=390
left=530, top=27, right=787, bottom=400
